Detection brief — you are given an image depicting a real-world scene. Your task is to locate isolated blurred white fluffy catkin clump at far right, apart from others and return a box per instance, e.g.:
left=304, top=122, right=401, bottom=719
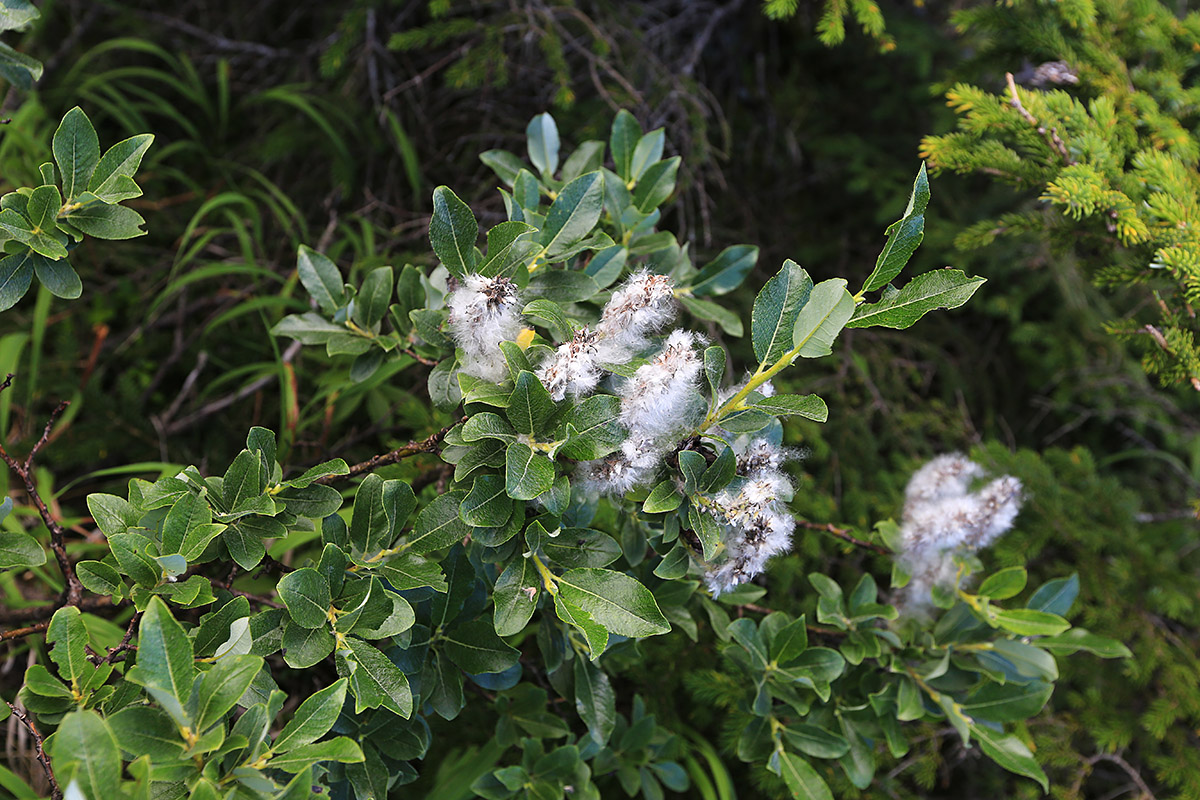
left=900, top=453, right=1022, bottom=614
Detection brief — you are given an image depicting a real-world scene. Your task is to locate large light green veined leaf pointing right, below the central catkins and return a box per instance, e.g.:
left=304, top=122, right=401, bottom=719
left=558, top=569, right=671, bottom=637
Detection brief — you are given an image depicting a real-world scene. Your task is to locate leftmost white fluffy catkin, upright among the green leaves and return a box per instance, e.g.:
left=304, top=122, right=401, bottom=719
left=446, top=275, right=522, bottom=381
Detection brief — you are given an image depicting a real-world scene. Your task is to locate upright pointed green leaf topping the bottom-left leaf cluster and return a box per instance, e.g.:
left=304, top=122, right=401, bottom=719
left=128, top=597, right=196, bottom=724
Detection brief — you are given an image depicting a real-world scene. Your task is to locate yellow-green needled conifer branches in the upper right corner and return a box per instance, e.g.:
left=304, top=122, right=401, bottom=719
left=922, top=0, right=1200, bottom=390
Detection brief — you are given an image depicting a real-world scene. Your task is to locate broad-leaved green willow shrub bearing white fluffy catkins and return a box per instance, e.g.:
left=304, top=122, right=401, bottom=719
left=0, top=94, right=1127, bottom=800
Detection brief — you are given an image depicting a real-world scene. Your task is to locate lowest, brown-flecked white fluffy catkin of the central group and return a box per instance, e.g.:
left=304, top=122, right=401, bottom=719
left=704, top=439, right=796, bottom=597
